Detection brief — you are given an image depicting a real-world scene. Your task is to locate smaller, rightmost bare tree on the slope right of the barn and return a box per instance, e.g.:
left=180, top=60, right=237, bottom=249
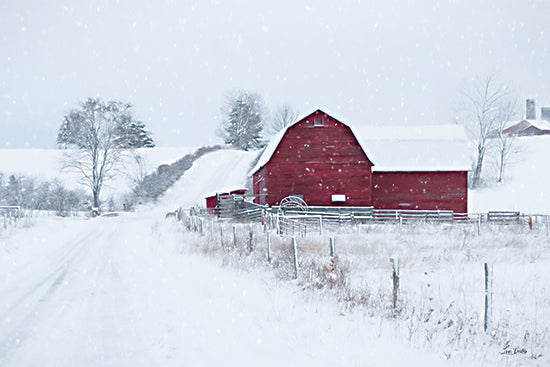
left=495, top=99, right=521, bottom=182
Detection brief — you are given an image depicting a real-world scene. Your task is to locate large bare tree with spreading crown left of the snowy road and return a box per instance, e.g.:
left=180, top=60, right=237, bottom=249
left=57, top=98, right=154, bottom=208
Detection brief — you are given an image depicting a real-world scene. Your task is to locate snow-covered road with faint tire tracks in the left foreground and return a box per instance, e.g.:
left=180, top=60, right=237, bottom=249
left=0, top=215, right=448, bottom=366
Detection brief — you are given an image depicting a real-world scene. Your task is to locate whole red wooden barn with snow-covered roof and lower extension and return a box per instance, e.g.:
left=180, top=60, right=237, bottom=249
left=251, top=110, right=469, bottom=213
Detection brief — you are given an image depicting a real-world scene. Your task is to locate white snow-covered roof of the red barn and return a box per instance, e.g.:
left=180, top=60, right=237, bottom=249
left=249, top=111, right=471, bottom=175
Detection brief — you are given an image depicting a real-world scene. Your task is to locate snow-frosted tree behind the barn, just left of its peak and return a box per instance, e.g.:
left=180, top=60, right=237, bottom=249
left=220, top=90, right=266, bottom=150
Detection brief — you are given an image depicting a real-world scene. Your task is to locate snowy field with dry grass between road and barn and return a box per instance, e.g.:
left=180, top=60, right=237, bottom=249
left=178, top=217, right=550, bottom=365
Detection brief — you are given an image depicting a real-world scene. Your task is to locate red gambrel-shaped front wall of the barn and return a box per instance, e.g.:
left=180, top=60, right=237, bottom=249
left=254, top=111, right=372, bottom=206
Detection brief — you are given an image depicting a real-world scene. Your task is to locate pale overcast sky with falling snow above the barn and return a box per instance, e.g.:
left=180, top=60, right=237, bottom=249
left=0, top=0, right=550, bottom=148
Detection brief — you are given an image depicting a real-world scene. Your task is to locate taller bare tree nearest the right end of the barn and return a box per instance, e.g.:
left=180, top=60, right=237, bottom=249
left=463, top=75, right=517, bottom=187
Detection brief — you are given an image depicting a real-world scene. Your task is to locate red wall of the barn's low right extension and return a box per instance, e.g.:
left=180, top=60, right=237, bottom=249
left=372, top=171, right=468, bottom=213
